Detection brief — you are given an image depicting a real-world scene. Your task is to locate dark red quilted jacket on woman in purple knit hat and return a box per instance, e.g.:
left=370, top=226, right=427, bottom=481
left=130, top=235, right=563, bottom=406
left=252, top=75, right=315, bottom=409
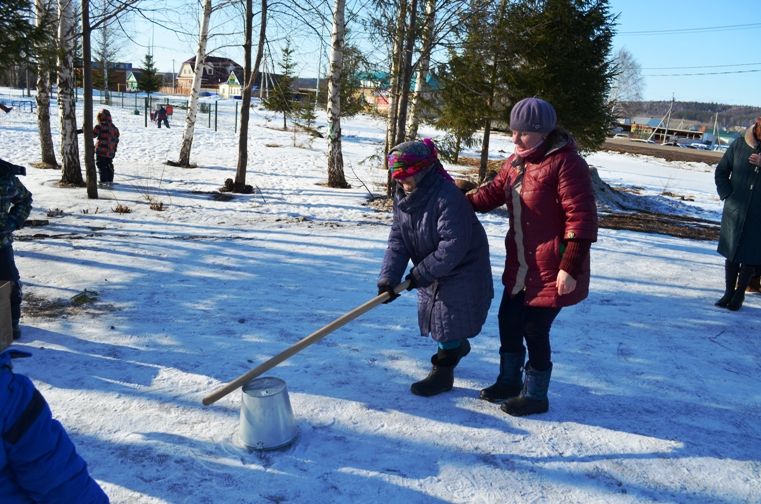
left=468, top=130, right=597, bottom=307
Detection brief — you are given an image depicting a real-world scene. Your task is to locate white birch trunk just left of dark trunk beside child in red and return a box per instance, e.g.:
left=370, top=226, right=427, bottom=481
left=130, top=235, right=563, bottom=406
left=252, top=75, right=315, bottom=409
left=58, top=0, right=84, bottom=186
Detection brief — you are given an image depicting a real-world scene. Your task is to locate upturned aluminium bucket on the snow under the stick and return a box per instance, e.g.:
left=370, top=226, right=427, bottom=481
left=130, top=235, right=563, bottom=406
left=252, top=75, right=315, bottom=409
left=240, top=377, right=297, bottom=450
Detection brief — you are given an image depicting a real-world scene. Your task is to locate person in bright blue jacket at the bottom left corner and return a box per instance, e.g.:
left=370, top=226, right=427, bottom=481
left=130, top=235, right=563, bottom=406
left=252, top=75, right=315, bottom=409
left=0, top=350, right=109, bottom=504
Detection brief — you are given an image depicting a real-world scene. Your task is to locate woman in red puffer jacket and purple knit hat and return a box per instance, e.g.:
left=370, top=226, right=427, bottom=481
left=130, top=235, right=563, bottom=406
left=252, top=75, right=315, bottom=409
left=468, top=98, right=597, bottom=416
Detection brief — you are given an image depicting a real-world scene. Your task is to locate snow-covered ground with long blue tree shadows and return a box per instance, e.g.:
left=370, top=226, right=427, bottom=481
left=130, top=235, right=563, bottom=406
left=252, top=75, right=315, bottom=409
left=0, top=95, right=761, bottom=504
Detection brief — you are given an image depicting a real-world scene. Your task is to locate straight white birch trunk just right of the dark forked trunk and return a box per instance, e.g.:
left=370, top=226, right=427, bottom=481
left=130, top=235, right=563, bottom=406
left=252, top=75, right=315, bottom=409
left=328, top=0, right=349, bottom=188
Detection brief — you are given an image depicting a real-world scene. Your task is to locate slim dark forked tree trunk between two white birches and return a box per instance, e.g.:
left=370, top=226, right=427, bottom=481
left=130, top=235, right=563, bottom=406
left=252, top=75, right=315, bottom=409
left=233, top=0, right=267, bottom=192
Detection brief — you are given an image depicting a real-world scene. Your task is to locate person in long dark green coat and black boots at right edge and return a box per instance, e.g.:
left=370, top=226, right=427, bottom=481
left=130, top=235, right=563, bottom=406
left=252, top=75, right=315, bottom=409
left=714, top=117, right=761, bottom=311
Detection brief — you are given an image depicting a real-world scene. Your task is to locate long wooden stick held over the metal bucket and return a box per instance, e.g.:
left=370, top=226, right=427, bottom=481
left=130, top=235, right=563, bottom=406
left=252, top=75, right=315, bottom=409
left=202, top=280, right=410, bottom=406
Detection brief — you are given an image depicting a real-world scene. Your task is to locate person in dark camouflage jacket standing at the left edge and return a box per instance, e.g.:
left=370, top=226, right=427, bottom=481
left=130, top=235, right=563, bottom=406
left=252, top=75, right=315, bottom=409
left=0, top=159, right=32, bottom=339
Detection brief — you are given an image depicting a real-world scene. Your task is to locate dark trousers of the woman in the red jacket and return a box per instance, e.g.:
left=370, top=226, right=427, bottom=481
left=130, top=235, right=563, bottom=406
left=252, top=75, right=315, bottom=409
left=499, top=291, right=560, bottom=371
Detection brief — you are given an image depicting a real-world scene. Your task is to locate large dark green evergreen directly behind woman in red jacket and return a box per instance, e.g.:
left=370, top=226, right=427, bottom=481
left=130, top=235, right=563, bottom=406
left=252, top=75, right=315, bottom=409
left=503, top=0, right=615, bottom=149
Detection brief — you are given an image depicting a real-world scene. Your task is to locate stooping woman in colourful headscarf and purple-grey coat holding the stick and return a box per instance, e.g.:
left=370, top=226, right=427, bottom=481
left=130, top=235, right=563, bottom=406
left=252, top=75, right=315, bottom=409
left=378, top=138, right=494, bottom=397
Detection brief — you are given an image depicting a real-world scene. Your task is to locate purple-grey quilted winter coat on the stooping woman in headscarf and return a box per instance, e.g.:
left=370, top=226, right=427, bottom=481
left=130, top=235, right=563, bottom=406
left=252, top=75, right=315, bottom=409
left=378, top=169, right=494, bottom=341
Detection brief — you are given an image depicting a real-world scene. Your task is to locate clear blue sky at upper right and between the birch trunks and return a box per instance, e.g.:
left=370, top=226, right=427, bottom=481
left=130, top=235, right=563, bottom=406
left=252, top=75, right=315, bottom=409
left=127, top=0, right=761, bottom=106
